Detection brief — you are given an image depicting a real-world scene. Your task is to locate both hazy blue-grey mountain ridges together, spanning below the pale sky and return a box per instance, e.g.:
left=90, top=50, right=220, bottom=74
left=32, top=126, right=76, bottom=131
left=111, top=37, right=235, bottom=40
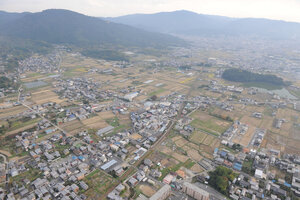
left=0, top=9, right=300, bottom=51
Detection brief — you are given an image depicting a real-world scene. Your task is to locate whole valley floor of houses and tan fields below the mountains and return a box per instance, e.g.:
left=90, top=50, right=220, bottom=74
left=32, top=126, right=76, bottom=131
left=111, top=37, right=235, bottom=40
left=0, top=4, right=300, bottom=200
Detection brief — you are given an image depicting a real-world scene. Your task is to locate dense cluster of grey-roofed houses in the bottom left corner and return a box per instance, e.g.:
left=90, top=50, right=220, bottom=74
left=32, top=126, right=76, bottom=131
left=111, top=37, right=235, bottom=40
left=3, top=128, right=106, bottom=200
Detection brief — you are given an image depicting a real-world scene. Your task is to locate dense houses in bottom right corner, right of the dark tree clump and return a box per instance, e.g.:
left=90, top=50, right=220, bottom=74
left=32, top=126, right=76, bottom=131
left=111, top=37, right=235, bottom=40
left=209, top=145, right=300, bottom=200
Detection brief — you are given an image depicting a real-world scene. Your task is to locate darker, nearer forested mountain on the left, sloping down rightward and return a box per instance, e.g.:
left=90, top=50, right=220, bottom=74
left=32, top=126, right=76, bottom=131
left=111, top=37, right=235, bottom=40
left=0, top=9, right=184, bottom=47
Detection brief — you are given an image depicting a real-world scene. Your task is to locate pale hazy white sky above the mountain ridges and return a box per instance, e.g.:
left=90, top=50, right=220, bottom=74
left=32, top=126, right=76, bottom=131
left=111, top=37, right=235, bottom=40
left=0, top=0, right=300, bottom=22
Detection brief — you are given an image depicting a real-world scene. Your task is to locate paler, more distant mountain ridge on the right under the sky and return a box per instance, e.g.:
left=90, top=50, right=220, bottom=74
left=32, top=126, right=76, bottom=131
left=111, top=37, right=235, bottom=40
left=106, top=10, right=300, bottom=40
